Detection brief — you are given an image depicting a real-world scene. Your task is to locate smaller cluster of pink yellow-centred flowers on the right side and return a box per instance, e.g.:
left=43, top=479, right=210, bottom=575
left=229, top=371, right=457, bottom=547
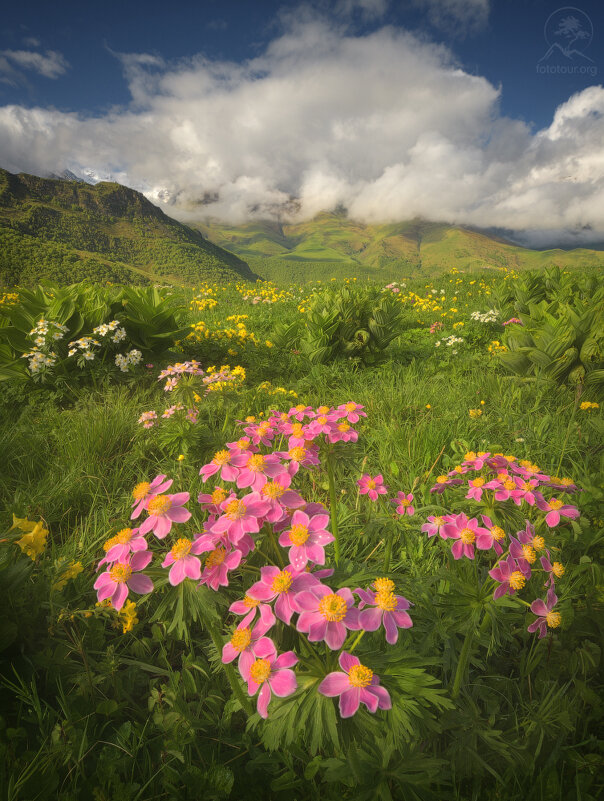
left=422, top=451, right=579, bottom=637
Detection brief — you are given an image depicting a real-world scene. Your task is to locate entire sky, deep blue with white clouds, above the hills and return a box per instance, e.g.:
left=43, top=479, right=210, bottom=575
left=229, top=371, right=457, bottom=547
left=0, top=0, right=604, bottom=244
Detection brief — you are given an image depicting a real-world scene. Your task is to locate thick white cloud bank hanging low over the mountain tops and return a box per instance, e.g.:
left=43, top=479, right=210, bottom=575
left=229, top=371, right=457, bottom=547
left=0, top=15, right=604, bottom=245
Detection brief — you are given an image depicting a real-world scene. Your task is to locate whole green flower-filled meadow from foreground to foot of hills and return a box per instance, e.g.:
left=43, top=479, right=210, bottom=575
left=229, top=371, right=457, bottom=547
left=0, top=268, right=604, bottom=801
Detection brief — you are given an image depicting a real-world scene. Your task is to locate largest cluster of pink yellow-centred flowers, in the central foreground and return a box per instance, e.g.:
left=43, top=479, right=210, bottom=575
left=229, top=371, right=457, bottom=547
left=95, top=402, right=412, bottom=717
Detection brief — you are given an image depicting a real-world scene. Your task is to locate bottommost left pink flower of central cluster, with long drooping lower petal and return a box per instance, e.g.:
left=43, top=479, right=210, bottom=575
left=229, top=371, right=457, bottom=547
left=241, top=637, right=298, bottom=718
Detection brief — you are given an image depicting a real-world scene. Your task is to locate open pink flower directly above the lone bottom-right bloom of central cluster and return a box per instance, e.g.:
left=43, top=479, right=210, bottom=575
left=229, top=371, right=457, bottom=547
left=296, top=584, right=360, bottom=651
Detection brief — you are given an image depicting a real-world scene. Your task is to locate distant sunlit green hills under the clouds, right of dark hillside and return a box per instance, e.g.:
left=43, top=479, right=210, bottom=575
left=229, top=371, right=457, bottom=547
left=194, top=212, right=604, bottom=280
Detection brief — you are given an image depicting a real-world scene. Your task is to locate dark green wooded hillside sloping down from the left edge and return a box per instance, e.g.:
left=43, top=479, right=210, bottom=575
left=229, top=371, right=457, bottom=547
left=0, top=169, right=257, bottom=285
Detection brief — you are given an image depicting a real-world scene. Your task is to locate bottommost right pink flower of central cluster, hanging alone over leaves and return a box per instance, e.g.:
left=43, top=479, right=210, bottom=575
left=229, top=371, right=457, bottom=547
left=318, top=651, right=392, bottom=718
